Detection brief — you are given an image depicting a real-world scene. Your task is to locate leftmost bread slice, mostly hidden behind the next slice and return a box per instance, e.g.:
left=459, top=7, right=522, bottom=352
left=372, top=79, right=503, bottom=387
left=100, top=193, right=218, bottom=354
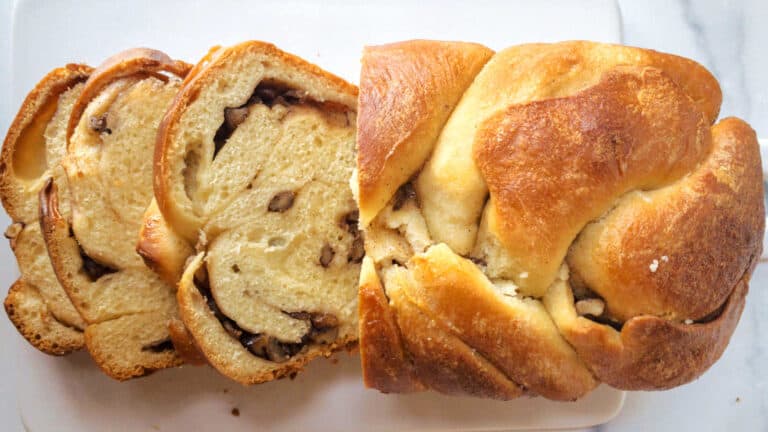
left=0, top=64, right=92, bottom=355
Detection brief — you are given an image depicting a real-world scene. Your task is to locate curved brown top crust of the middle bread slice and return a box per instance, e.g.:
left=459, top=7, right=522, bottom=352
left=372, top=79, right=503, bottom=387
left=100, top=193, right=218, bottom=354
left=67, top=48, right=192, bottom=142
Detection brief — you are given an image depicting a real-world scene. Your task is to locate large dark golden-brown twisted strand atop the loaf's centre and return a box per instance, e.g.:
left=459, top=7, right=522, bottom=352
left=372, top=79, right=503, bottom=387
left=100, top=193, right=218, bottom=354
left=474, top=68, right=711, bottom=296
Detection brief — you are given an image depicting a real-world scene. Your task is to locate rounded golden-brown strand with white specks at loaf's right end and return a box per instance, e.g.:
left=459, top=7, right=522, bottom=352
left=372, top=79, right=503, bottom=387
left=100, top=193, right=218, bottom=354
left=568, top=118, right=765, bottom=321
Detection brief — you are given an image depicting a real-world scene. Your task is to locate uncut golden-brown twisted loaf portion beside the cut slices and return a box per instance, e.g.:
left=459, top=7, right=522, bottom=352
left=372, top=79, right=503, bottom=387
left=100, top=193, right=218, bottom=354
left=353, top=41, right=765, bottom=400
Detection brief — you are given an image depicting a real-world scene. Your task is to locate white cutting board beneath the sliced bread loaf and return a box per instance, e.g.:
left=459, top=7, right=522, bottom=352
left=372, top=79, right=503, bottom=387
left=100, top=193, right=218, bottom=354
left=6, top=0, right=624, bottom=432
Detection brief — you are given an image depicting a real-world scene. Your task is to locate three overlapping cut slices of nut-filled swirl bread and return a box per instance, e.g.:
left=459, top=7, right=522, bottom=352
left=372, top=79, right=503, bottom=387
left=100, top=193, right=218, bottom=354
left=2, top=42, right=364, bottom=383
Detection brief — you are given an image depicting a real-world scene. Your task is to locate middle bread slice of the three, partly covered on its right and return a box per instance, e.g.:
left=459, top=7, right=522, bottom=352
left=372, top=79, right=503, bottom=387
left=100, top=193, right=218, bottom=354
left=40, top=48, right=194, bottom=380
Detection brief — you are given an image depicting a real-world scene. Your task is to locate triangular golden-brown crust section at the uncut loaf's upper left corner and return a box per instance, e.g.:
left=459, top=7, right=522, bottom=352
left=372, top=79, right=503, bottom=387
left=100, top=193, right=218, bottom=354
left=357, top=40, right=493, bottom=226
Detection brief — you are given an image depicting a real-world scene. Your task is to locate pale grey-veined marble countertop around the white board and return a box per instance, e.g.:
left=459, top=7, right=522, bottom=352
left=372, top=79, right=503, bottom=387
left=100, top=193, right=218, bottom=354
left=0, top=0, right=768, bottom=431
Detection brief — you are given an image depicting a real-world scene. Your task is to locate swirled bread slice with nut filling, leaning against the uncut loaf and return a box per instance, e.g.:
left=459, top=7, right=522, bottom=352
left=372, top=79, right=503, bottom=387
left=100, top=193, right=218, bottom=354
left=139, top=42, right=363, bottom=384
